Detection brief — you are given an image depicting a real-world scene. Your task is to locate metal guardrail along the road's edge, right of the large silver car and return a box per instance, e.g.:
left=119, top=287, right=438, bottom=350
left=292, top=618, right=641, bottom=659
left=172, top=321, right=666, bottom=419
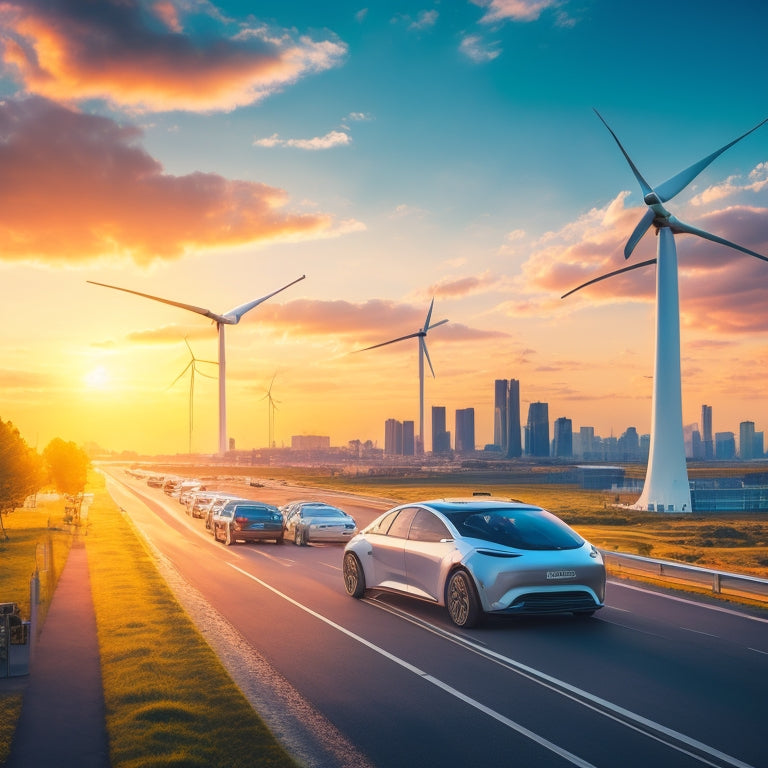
left=600, top=550, right=768, bottom=605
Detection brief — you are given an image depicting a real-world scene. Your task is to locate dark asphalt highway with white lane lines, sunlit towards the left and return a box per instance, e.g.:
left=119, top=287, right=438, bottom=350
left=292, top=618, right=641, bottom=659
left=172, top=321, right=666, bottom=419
left=102, top=470, right=768, bottom=768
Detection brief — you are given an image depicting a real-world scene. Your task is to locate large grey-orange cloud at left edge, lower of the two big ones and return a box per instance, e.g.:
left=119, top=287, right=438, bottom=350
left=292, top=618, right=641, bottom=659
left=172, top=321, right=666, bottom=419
left=0, top=97, right=362, bottom=264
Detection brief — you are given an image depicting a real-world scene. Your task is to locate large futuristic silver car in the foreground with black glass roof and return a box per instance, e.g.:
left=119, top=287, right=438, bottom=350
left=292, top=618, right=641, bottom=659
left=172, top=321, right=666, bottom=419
left=342, top=497, right=605, bottom=628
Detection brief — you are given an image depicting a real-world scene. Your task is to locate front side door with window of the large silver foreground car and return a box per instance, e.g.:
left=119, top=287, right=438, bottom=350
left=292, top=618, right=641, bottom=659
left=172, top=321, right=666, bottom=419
left=404, top=509, right=456, bottom=601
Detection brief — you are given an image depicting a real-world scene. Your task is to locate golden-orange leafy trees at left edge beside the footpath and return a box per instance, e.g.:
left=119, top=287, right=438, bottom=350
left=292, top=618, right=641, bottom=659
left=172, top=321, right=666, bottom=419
left=0, top=419, right=91, bottom=539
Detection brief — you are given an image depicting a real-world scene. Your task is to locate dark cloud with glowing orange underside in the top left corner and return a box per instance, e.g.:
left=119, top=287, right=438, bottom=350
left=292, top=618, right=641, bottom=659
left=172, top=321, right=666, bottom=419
left=0, top=0, right=347, bottom=112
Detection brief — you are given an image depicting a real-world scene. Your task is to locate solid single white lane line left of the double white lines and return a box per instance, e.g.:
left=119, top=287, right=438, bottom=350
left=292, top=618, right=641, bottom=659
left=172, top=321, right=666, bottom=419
left=227, top=563, right=596, bottom=768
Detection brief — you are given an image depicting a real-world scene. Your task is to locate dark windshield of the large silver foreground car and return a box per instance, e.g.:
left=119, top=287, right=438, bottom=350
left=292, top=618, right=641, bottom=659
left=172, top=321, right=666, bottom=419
left=449, top=507, right=584, bottom=550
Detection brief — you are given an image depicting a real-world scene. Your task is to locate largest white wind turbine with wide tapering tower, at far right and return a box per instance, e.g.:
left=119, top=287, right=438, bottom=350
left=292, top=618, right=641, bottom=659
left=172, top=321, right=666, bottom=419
left=562, top=110, right=768, bottom=512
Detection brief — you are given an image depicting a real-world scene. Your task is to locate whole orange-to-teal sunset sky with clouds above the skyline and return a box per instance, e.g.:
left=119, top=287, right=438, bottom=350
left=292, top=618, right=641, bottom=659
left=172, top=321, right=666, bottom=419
left=0, top=0, right=768, bottom=453
